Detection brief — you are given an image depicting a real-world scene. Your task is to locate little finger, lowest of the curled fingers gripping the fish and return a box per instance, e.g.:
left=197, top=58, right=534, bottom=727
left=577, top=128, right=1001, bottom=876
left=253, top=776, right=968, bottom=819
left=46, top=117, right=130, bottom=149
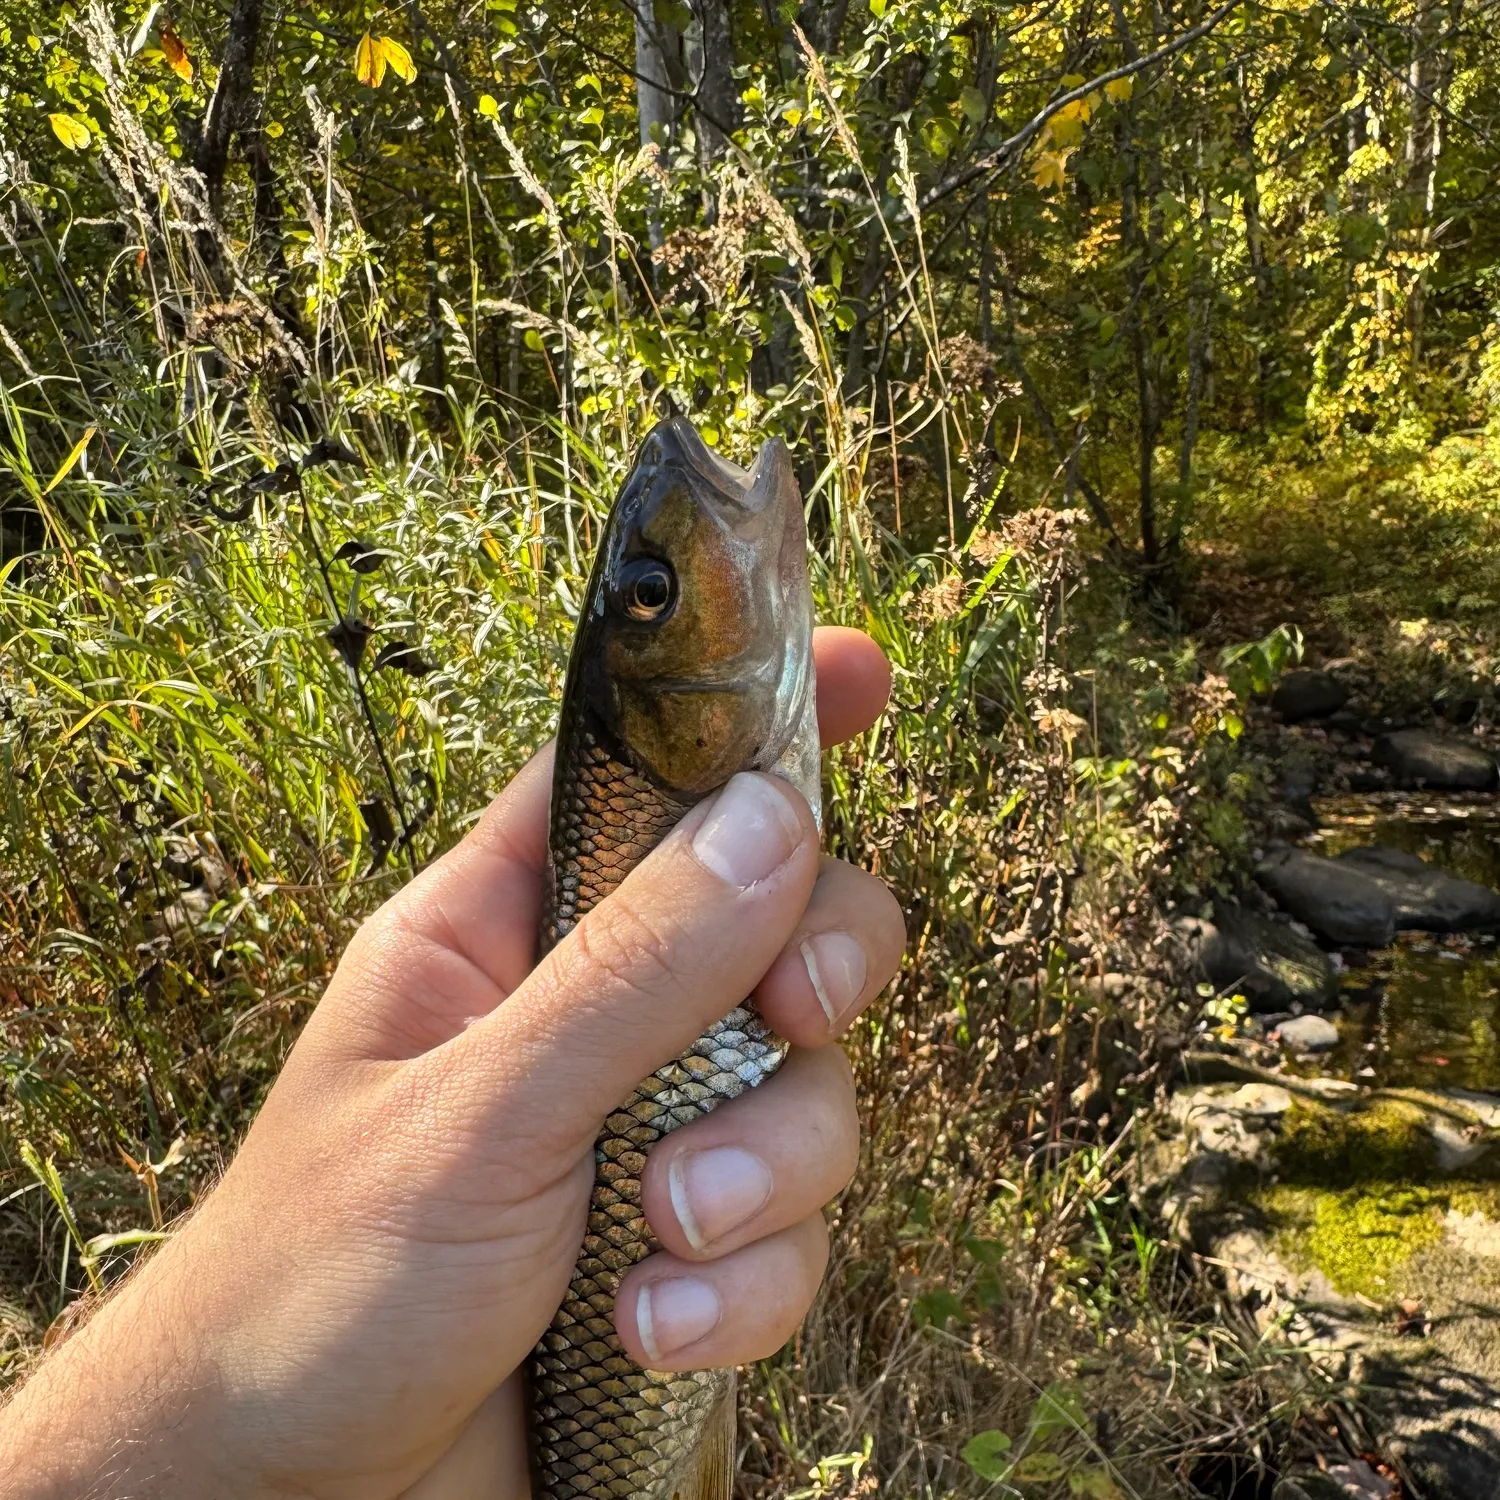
left=615, top=1214, right=828, bottom=1370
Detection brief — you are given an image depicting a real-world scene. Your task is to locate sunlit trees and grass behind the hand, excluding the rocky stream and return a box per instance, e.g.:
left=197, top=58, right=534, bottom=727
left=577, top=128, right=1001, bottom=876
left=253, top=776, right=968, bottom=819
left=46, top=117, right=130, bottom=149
left=0, top=0, right=1500, bottom=1497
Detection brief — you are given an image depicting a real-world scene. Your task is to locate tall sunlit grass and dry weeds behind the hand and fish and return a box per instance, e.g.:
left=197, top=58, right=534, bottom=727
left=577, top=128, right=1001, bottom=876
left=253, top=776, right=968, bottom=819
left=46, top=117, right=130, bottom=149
left=0, top=12, right=1326, bottom=1497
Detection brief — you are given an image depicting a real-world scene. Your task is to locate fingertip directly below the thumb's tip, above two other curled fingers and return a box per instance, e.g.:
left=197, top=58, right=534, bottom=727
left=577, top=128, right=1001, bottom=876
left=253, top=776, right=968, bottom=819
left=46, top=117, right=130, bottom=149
left=755, top=858, right=906, bottom=1047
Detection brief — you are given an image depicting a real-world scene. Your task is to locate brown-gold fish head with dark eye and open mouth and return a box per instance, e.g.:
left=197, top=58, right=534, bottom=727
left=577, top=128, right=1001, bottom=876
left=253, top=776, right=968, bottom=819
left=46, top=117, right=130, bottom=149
left=579, top=419, right=813, bottom=797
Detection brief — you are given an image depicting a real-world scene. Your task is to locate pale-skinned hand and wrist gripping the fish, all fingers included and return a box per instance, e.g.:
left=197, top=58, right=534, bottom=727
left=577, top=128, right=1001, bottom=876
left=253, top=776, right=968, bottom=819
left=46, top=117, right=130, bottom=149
left=0, top=630, right=905, bottom=1500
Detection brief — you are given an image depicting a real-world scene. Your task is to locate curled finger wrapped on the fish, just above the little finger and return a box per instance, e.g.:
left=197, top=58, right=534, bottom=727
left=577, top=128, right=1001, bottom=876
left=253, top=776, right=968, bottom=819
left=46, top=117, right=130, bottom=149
left=641, top=1047, right=860, bottom=1260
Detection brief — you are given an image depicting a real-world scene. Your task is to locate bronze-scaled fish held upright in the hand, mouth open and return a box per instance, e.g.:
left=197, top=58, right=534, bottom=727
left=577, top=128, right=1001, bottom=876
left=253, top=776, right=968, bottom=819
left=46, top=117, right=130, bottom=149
left=527, top=417, right=821, bottom=1500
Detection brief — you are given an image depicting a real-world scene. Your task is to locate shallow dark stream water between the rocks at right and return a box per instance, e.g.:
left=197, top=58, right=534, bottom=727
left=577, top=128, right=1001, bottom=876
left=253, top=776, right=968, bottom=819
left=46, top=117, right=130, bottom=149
left=1307, top=792, right=1500, bottom=1092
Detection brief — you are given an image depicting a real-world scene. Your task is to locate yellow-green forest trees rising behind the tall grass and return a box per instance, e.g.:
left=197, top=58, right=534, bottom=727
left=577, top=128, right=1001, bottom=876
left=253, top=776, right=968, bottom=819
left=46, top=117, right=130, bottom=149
left=11, top=0, right=1497, bottom=561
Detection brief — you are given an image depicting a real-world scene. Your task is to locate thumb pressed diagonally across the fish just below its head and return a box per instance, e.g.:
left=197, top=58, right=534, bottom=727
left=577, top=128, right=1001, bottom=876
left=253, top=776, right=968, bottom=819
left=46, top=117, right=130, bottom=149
left=435, top=773, right=819, bottom=1137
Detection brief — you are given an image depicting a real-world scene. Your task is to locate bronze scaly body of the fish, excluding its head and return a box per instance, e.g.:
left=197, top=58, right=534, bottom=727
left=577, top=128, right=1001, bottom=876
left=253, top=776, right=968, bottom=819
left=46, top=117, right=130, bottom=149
left=530, top=725, right=786, bottom=1500
